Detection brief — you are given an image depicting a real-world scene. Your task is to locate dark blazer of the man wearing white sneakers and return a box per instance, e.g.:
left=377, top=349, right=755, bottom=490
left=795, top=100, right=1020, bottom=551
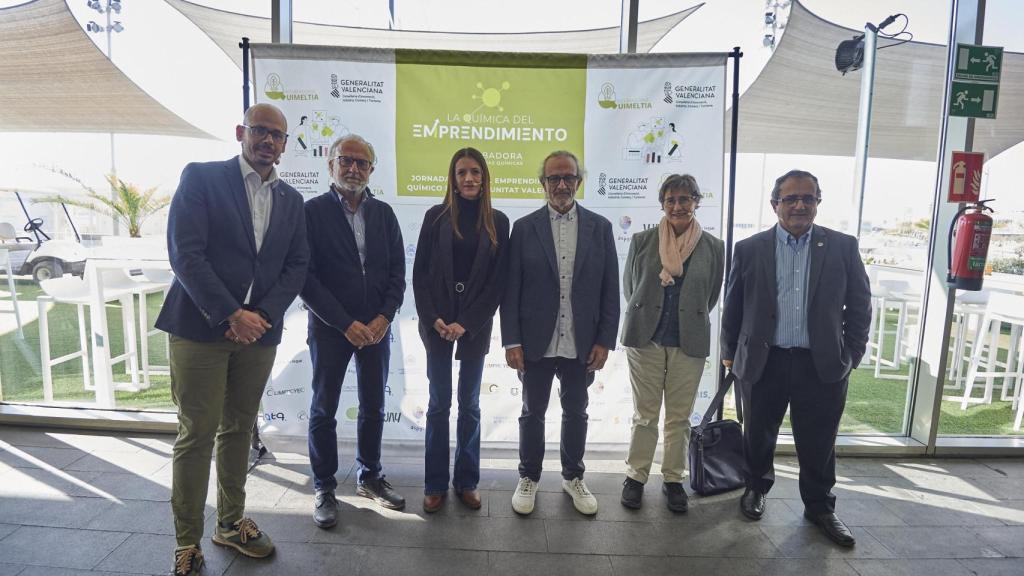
left=501, top=203, right=618, bottom=363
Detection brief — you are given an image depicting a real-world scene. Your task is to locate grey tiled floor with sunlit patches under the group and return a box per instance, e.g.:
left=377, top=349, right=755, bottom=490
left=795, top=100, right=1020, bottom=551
left=0, top=426, right=1024, bottom=576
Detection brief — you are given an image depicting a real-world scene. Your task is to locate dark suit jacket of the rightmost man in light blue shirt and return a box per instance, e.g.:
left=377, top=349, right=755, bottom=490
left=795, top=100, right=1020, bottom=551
left=722, top=224, right=871, bottom=385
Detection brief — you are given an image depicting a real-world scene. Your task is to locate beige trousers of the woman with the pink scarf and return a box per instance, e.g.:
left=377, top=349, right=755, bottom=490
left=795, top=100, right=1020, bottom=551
left=626, top=342, right=705, bottom=484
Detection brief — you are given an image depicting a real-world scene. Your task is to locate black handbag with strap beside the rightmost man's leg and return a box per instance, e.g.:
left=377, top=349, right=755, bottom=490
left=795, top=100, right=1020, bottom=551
left=689, top=372, right=744, bottom=496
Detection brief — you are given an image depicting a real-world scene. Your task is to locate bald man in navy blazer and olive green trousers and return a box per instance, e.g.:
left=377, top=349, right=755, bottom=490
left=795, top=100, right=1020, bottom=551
left=157, top=104, right=309, bottom=576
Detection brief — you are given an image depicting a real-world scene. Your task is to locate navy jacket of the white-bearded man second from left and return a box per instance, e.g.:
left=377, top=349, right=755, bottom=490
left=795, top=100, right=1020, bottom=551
left=302, top=190, right=406, bottom=337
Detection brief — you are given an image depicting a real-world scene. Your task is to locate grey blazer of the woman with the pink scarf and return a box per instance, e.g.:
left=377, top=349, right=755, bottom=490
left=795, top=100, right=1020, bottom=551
left=623, top=227, right=725, bottom=358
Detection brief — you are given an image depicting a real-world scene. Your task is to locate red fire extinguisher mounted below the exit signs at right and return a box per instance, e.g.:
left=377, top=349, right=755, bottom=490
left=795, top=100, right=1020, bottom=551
left=946, top=199, right=994, bottom=290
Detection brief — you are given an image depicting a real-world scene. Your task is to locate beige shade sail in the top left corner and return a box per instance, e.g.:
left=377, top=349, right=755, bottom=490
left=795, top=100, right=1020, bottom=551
left=0, top=0, right=212, bottom=138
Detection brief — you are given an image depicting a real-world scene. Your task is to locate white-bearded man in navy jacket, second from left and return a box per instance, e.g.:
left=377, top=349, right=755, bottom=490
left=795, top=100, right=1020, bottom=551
left=302, top=134, right=406, bottom=528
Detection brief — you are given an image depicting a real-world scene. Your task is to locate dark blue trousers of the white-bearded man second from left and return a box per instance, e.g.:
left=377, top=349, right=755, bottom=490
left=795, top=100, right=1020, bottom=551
left=307, top=329, right=391, bottom=490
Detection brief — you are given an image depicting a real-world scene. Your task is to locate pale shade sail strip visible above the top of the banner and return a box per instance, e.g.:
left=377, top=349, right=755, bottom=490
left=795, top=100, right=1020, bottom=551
left=166, top=0, right=703, bottom=68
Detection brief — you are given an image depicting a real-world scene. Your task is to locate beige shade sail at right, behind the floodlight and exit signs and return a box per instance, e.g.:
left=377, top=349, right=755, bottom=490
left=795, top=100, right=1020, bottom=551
left=738, top=1, right=1024, bottom=161
